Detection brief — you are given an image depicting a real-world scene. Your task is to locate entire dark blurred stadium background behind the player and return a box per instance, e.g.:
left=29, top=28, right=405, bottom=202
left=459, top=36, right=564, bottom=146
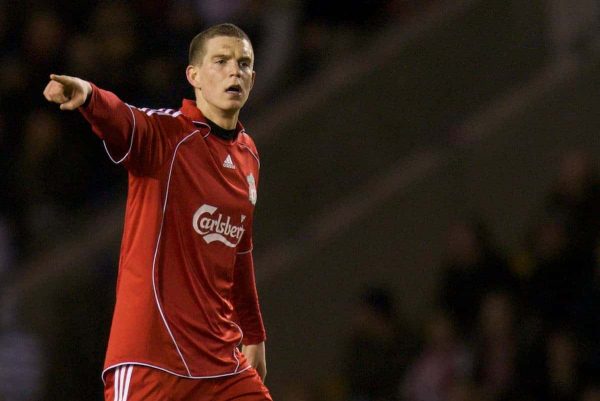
left=0, top=0, right=600, bottom=401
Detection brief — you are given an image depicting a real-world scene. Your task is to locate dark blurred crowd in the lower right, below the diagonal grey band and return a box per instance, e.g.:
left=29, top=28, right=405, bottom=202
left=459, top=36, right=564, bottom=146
left=330, top=151, right=600, bottom=401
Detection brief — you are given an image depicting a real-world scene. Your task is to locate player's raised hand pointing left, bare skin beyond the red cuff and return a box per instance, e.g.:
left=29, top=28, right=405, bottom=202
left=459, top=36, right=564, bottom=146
left=44, top=74, right=92, bottom=110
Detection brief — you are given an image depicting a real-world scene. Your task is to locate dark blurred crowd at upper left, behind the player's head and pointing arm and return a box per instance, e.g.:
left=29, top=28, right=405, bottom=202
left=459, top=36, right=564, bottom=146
left=0, top=0, right=427, bottom=276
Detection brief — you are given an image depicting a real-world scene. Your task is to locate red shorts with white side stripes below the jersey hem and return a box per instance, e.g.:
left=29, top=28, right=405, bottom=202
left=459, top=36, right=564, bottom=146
left=104, top=365, right=273, bottom=401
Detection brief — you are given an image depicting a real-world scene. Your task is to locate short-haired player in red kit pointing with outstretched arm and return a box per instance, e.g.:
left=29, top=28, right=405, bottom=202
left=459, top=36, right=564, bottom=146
left=44, top=24, right=271, bottom=401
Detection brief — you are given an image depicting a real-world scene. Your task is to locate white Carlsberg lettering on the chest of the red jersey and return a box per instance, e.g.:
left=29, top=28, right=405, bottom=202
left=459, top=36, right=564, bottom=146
left=192, top=205, right=246, bottom=248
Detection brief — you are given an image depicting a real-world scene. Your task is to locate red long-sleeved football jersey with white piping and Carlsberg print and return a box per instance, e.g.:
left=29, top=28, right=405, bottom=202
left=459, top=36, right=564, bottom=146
left=80, top=85, right=265, bottom=378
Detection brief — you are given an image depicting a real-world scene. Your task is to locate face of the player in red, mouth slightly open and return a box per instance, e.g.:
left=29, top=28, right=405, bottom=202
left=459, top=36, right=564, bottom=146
left=187, top=36, right=255, bottom=118
